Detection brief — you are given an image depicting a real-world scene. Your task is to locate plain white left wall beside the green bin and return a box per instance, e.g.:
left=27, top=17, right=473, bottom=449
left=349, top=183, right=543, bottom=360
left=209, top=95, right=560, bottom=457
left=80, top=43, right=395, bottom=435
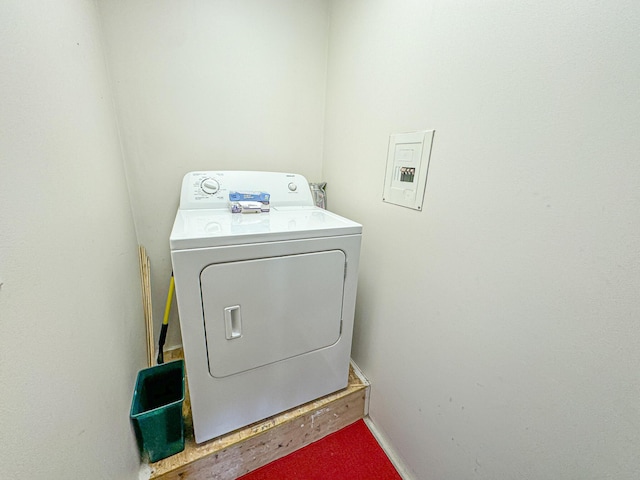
left=0, top=0, right=145, bottom=479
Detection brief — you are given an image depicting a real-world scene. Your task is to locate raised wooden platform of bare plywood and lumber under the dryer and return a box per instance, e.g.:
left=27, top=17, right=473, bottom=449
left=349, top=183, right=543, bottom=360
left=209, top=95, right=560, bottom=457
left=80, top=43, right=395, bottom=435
left=150, top=349, right=369, bottom=480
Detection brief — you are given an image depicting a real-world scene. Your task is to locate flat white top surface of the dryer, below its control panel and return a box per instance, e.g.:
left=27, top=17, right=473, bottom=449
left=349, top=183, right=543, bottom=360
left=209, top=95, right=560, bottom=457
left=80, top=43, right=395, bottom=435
left=170, top=206, right=362, bottom=250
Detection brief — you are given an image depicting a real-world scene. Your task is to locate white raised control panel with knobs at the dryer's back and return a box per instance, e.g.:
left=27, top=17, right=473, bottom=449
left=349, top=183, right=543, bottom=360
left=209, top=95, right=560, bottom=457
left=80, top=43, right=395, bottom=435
left=180, top=171, right=314, bottom=210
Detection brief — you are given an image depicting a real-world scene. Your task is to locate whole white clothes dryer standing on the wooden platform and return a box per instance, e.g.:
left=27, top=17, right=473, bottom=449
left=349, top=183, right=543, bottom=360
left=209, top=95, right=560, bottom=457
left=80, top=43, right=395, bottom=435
left=170, top=171, right=362, bottom=443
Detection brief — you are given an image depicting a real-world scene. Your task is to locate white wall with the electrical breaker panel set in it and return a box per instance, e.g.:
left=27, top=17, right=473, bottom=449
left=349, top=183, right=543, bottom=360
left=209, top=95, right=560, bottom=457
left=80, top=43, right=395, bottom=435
left=323, top=0, right=640, bottom=480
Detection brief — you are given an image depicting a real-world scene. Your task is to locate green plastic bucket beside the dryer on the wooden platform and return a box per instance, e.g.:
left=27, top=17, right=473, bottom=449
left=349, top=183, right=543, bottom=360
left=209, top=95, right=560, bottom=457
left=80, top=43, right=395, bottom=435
left=131, top=360, right=185, bottom=462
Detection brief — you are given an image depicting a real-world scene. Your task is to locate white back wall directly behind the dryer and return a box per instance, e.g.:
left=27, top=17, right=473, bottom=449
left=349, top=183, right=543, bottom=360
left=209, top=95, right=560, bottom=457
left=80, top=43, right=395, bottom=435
left=98, top=0, right=327, bottom=345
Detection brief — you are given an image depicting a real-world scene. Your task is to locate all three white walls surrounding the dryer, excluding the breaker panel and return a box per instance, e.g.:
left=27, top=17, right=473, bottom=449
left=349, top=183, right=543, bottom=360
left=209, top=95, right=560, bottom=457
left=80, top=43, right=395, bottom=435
left=0, top=0, right=640, bottom=479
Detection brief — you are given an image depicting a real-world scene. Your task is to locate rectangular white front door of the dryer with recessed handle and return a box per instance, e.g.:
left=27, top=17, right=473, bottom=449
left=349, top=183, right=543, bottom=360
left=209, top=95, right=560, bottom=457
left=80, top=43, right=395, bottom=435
left=200, top=250, right=346, bottom=377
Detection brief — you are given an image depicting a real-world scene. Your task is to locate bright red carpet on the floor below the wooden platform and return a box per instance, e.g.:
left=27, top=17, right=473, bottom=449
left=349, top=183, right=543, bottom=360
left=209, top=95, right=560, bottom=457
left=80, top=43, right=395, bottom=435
left=239, top=420, right=401, bottom=480
